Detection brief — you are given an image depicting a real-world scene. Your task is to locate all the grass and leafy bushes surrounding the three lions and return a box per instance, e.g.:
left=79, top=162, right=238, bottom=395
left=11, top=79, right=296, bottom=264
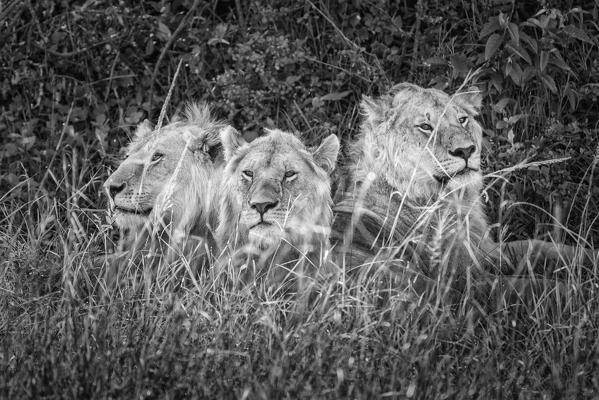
left=0, top=0, right=599, bottom=398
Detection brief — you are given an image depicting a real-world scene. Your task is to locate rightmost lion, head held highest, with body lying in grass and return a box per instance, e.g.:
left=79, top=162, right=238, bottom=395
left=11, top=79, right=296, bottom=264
left=331, top=83, right=593, bottom=296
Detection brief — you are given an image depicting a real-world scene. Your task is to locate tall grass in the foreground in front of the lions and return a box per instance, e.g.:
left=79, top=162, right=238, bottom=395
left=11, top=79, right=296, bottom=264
left=0, top=143, right=599, bottom=398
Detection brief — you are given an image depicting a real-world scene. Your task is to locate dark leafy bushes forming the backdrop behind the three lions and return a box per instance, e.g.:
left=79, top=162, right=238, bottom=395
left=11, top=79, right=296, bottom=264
left=0, top=0, right=599, bottom=242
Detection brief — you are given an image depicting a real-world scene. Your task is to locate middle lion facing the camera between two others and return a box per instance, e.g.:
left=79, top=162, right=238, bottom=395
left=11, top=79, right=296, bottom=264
left=217, top=129, right=339, bottom=288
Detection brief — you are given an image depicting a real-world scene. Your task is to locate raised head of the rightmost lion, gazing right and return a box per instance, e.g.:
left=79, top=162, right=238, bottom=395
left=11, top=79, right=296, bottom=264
left=358, top=83, right=482, bottom=200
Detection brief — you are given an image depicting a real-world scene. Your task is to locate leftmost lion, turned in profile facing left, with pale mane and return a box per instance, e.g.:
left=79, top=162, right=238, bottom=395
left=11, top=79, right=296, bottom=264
left=104, top=103, right=234, bottom=260
